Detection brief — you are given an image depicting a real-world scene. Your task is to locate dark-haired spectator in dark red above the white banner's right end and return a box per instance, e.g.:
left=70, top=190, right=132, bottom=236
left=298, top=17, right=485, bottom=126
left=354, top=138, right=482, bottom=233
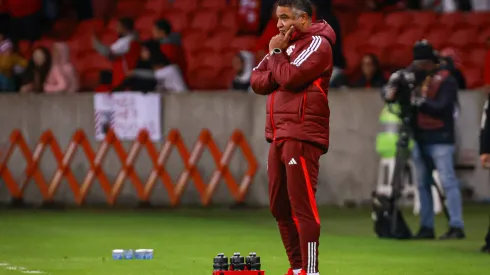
left=152, top=19, right=187, bottom=76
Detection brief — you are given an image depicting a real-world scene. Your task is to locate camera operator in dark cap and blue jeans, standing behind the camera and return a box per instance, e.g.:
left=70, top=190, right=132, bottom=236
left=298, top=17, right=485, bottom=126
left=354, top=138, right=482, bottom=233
left=383, top=40, right=465, bottom=239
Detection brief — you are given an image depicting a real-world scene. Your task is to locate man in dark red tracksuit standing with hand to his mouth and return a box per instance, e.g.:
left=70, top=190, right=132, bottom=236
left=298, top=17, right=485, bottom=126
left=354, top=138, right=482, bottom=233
left=251, top=0, right=336, bottom=275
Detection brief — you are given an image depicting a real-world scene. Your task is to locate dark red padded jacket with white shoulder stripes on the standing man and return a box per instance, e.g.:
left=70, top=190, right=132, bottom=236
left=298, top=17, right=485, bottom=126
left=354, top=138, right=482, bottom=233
left=251, top=20, right=336, bottom=152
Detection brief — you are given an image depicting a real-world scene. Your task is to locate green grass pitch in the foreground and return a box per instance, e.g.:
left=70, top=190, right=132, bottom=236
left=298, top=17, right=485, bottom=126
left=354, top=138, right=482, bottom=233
left=0, top=206, right=490, bottom=275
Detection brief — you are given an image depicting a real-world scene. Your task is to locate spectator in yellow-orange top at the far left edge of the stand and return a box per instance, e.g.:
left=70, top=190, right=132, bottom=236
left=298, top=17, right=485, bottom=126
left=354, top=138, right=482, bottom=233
left=0, top=39, right=27, bottom=92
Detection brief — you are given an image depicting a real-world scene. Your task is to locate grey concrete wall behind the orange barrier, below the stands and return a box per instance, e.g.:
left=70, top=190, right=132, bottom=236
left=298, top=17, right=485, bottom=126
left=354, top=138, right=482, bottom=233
left=0, top=90, right=490, bottom=205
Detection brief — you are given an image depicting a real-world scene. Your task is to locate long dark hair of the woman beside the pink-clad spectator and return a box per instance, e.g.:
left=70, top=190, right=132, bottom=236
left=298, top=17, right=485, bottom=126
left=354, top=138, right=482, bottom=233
left=23, top=47, right=52, bottom=93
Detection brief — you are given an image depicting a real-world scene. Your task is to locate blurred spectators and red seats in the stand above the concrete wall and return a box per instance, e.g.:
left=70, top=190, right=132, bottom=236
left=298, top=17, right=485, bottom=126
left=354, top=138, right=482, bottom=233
left=0, top=0, right=490, bottom=93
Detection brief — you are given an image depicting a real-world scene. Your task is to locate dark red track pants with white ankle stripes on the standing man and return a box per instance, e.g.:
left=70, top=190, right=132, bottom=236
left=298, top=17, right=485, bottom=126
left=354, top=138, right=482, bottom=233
left=267, top=140, right=323, bottom=273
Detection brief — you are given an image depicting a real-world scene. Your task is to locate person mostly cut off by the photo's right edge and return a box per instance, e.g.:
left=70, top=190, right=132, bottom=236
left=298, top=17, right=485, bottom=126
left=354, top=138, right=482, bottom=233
left=480, top=90, right=490, bottom=253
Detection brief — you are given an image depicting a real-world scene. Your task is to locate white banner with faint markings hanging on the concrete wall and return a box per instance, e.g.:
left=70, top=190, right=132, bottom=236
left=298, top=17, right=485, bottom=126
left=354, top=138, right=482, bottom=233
left=94, top=92, right=162, bottom=141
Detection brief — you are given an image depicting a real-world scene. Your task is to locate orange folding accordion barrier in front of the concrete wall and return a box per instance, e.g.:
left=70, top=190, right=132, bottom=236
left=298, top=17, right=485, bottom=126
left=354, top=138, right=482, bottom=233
left=0, top=129, right=257, bottom=206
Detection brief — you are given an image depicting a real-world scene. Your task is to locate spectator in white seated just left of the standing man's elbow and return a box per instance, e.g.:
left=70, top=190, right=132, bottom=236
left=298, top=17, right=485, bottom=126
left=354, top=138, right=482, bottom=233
left=231, top=51, right=255, bottom=91
